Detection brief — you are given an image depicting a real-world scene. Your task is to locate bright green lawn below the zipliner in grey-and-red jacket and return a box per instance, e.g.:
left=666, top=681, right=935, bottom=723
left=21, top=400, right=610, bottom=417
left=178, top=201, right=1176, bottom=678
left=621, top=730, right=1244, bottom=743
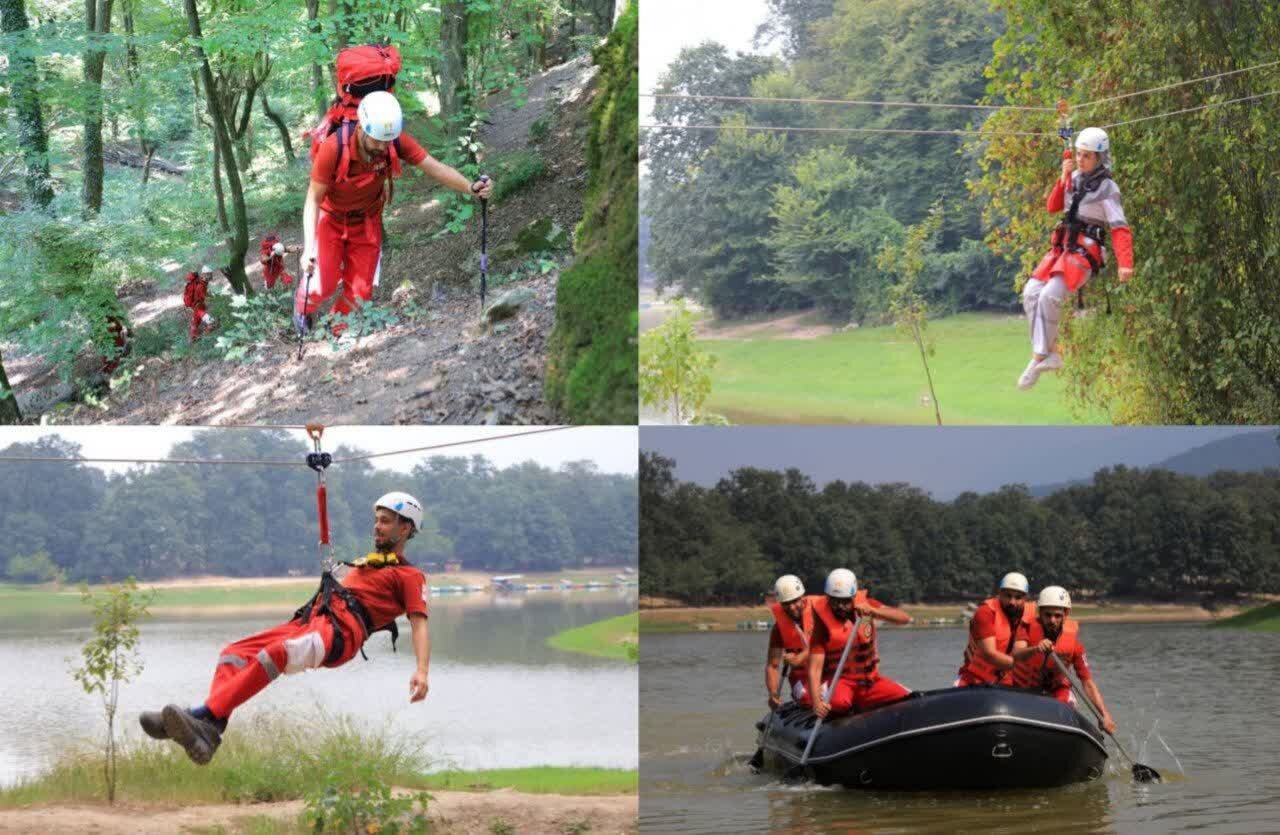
left=698, top=314, right=1107, bottom=425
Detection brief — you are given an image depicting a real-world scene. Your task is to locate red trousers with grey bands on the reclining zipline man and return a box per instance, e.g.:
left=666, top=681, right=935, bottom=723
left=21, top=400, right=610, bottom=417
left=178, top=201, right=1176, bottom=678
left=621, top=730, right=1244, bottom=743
left=205, top=601, right=364, bottom=718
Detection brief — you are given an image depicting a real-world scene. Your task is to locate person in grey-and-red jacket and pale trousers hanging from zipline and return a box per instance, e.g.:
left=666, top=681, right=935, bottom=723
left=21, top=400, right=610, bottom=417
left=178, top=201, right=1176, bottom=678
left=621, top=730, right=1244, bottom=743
left=1018, top=128, right=1133, bottom=391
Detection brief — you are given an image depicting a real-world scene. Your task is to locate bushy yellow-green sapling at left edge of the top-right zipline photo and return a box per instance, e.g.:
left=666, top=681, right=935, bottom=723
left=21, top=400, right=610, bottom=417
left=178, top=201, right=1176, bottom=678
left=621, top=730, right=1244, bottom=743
left=640, top=298, right=716, bottom=424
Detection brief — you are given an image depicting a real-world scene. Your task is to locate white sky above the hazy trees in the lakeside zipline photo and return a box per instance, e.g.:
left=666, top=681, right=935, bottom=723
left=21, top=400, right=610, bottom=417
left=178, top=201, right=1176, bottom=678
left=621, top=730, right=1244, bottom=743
left=0, top=426, right=637, bottom=474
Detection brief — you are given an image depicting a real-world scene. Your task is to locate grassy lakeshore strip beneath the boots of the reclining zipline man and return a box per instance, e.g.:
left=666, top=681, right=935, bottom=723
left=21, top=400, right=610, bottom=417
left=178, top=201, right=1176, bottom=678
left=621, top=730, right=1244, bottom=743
left=0, top=715, right=639, bottom=808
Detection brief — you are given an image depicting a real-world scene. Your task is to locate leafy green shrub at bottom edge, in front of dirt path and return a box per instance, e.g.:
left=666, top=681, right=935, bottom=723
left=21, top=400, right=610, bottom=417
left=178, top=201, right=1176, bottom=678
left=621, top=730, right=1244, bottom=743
left=306, top=767, right=431, bottom=832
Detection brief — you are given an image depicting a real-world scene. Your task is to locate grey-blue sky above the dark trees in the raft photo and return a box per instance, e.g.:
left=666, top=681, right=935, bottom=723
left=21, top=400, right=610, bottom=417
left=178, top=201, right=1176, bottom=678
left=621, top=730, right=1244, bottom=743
left=640, top=426, right=1258, bottom=501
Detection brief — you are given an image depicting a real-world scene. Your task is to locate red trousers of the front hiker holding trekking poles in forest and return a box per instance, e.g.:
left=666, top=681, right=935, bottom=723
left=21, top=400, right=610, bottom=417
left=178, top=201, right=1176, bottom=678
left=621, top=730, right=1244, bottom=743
left=297, top=210, right=383, bottom=321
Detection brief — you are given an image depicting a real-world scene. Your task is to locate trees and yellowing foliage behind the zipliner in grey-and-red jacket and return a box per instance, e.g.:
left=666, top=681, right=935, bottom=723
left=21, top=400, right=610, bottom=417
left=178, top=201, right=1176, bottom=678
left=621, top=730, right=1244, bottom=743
left=641, top=0, right=1280, bottom=424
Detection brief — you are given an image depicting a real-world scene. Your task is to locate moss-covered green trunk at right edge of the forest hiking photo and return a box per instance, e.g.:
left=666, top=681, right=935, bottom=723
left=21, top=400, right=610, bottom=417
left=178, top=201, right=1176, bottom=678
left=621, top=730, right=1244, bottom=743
left=544, top=0, right=640, bottom=424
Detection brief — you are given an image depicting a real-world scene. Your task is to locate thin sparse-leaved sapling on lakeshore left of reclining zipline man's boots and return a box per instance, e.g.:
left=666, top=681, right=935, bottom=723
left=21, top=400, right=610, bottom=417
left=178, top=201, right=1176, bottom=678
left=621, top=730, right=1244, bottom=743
left=72, top=576, right=151, bottom=803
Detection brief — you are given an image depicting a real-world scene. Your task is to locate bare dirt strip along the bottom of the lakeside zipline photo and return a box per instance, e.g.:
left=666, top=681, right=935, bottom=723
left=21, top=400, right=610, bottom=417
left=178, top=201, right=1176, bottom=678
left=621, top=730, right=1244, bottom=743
left=0, top=790, right=640, bottom=835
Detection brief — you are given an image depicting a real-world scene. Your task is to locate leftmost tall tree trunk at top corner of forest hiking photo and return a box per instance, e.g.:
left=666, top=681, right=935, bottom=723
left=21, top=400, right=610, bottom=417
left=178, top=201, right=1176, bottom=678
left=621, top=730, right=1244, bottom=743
left=0, top=0, right=54, bottom=210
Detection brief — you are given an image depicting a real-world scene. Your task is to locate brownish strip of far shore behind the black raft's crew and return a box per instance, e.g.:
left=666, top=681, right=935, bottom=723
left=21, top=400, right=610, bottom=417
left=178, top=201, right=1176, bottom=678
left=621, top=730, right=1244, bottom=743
left=640, top=603, right=1228, bottom=634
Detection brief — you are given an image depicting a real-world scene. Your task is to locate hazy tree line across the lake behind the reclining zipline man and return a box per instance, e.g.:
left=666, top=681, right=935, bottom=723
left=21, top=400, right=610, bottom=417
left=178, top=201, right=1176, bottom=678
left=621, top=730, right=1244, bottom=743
left=0, top=430, right=637, bottom=583
